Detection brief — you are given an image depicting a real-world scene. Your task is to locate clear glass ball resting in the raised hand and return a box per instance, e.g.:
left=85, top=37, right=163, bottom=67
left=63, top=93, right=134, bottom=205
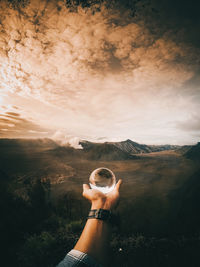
left=89, top=167, right=116, bottom=194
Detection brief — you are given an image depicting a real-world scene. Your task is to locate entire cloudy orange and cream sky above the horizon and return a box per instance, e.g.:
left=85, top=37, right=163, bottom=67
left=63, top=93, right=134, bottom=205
left=0, top=0, right=200, bottom=144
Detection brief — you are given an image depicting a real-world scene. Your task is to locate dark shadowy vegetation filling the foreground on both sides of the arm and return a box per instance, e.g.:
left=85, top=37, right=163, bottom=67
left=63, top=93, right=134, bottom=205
left=0, top=168, right=200, bottom=267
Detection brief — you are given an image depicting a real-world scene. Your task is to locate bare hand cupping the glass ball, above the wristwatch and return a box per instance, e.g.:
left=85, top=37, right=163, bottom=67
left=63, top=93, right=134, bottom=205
left=83, top=179, right=122, bottom=210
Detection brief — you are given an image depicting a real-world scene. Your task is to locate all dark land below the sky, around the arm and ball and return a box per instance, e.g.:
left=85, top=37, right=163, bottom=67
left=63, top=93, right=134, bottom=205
left=0, top=140, right=200, bottom=267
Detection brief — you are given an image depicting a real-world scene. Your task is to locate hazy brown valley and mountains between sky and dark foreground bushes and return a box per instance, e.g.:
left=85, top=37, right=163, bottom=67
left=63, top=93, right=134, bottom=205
left=0, top=139, right=199, bottom=224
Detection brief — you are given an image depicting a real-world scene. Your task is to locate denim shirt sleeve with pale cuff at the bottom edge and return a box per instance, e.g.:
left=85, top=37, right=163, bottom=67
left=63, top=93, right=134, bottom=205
left=56, top=249, right=103, bottom=267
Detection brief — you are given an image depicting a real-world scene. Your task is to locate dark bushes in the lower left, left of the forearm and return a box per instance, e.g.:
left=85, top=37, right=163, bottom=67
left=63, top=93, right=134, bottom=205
left=0, top=177, right=83, bottom=267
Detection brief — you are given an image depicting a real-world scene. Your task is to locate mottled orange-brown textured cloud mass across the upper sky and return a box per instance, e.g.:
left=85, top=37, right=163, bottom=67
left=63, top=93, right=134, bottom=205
left=1, top=1, right=195, bottom=104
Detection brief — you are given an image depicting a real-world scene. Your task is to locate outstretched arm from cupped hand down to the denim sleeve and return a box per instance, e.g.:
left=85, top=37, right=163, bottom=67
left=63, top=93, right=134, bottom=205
left=59, top=180, right=122, bottom=267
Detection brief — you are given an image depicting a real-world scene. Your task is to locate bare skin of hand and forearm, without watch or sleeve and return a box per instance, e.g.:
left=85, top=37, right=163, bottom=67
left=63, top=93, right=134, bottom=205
left=74, top=180, right=122, bottom=264
